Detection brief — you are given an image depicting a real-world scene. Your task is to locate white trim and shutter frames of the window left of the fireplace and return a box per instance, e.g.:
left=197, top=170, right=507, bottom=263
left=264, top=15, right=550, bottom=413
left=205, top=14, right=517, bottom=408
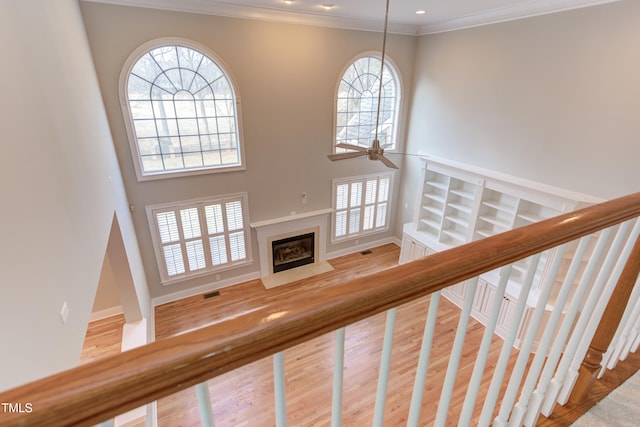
left=145, top=192, right=253, bottom=285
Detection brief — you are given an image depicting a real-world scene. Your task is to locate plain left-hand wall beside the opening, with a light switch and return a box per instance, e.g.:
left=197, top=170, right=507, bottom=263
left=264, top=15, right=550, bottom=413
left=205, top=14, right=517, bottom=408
left=0, top=0, right=149, bottom=390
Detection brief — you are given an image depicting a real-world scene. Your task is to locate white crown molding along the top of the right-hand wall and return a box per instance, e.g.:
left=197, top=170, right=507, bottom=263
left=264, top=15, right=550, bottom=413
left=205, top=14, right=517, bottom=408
left=416, top=0, right=620, bottom=35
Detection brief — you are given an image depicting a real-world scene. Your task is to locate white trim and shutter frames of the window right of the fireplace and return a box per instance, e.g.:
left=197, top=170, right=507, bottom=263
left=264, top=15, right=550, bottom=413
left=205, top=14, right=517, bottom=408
left=331, top=171, right=395, bottom=243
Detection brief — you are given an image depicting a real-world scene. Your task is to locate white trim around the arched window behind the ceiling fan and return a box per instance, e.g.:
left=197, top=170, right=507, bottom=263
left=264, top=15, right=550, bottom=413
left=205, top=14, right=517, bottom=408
left=331, top=51, right=404, bottom=154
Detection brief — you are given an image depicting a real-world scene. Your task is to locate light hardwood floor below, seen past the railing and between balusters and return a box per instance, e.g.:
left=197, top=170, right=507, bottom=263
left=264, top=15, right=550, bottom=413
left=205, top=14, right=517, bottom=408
left=85, top=244, right=640, bottom=427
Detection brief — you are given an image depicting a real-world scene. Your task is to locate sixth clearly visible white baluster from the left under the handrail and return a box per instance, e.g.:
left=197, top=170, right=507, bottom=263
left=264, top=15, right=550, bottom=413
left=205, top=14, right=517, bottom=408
left=434, top=277, right=478, bottom=426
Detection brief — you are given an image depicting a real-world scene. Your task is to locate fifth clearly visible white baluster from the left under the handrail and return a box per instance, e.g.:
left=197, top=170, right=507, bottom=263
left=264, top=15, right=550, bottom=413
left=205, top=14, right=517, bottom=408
left=407, top=291, right=440, bottom=427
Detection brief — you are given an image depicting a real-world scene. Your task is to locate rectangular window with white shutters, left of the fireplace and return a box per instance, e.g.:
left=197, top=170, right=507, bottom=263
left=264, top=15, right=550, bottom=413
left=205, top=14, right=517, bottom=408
left=147, top=194, right=251, bottom=282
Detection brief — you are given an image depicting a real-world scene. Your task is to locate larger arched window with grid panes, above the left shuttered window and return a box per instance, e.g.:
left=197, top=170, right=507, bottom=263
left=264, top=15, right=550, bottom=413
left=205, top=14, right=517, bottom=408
left=121, top=39, right=244, bottom=179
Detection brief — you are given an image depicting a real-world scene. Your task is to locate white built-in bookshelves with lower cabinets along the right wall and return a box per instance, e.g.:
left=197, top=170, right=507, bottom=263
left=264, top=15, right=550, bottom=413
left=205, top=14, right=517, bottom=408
left=400, top=157, right=601, bottom=352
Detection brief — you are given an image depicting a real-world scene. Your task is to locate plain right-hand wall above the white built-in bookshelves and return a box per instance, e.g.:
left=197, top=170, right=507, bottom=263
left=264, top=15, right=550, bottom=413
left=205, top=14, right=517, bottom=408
left=403, top=0, right=640, bottom=227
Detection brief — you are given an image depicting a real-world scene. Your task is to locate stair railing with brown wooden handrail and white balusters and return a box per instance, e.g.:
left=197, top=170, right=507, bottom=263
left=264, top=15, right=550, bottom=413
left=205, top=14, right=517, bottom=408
left=0, top=193, right=640, bottom=427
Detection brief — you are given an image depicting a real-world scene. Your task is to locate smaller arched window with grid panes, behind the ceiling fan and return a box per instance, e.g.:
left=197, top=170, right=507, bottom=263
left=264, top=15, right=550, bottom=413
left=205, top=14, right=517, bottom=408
left=335, top=56, right=400, bottom=152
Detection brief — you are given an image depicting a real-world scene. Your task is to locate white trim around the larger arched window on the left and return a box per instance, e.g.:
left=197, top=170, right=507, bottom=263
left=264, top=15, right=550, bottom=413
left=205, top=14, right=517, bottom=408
left=118, top=37, right=247, bottom=181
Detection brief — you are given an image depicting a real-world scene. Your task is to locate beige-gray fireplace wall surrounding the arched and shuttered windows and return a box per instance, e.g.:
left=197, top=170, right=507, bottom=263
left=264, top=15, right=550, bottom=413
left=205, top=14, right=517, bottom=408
left=81, top=2, right=416, bottom=297
